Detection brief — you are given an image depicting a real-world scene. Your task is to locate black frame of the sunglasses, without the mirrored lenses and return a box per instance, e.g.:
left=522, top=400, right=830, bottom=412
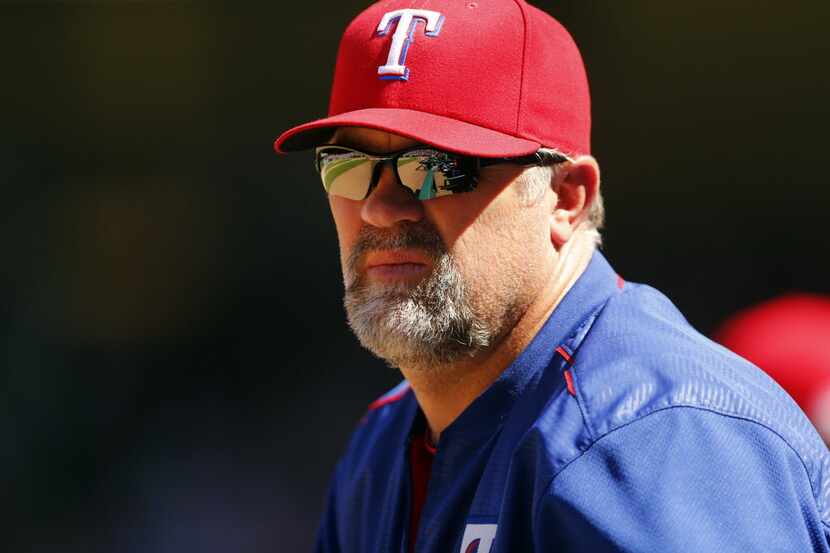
left=314, top=144, right=570, bottom=201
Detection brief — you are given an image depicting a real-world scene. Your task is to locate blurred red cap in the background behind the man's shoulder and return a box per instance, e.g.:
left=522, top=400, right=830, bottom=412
left=714, top=294, right=830, bottom=443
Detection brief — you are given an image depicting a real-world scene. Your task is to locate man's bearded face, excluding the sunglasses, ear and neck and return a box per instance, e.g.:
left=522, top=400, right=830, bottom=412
left=329, top=127, right=555, bottom=370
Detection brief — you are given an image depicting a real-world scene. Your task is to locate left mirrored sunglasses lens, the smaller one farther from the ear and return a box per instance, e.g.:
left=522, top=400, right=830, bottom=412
left=317, top=147, right=375, bottom=200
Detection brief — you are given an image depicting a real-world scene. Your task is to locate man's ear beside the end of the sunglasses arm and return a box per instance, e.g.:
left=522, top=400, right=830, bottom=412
left=550, top=156, right=599, bottom=250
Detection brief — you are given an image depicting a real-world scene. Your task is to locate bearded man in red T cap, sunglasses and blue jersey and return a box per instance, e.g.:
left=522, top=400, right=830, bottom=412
left=275, top=0, right=830, bottom=553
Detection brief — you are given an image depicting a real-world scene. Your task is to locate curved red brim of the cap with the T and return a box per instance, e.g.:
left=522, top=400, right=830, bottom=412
left=274, top=108, right=541, bottom=157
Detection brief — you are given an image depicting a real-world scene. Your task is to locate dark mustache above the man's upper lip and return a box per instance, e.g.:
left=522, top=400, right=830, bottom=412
left=346, top=221, right=447, bottom=275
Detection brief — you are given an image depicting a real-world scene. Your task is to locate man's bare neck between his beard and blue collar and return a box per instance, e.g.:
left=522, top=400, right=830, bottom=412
left=401, top=232, right=594, bottom=443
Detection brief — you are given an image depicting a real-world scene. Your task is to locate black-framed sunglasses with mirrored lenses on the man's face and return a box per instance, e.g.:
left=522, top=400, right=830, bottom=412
left=315, top=145, right=568, bottom=200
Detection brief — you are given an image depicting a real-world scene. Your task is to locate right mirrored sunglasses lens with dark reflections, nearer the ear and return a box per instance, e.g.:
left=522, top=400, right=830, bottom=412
left=398, top=149, right=472, bottom=200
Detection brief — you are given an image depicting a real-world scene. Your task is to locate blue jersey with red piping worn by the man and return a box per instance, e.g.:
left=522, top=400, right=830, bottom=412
left=317, top=253, right=830, bottom=553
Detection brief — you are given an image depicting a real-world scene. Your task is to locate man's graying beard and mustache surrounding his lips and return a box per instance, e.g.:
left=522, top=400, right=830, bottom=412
left=344, top=223, right=492, bottom=371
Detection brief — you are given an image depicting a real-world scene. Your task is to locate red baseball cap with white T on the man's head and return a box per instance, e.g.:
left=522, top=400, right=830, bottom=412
left=274, top=0, right=591, bottom=157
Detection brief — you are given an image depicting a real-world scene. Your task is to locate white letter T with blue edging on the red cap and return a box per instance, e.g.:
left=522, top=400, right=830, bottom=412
left=377, top=9, right=444, bottom=81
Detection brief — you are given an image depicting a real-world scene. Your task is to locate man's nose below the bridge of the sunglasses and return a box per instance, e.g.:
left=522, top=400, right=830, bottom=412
left=360, top=163, right=424, bottom=228
